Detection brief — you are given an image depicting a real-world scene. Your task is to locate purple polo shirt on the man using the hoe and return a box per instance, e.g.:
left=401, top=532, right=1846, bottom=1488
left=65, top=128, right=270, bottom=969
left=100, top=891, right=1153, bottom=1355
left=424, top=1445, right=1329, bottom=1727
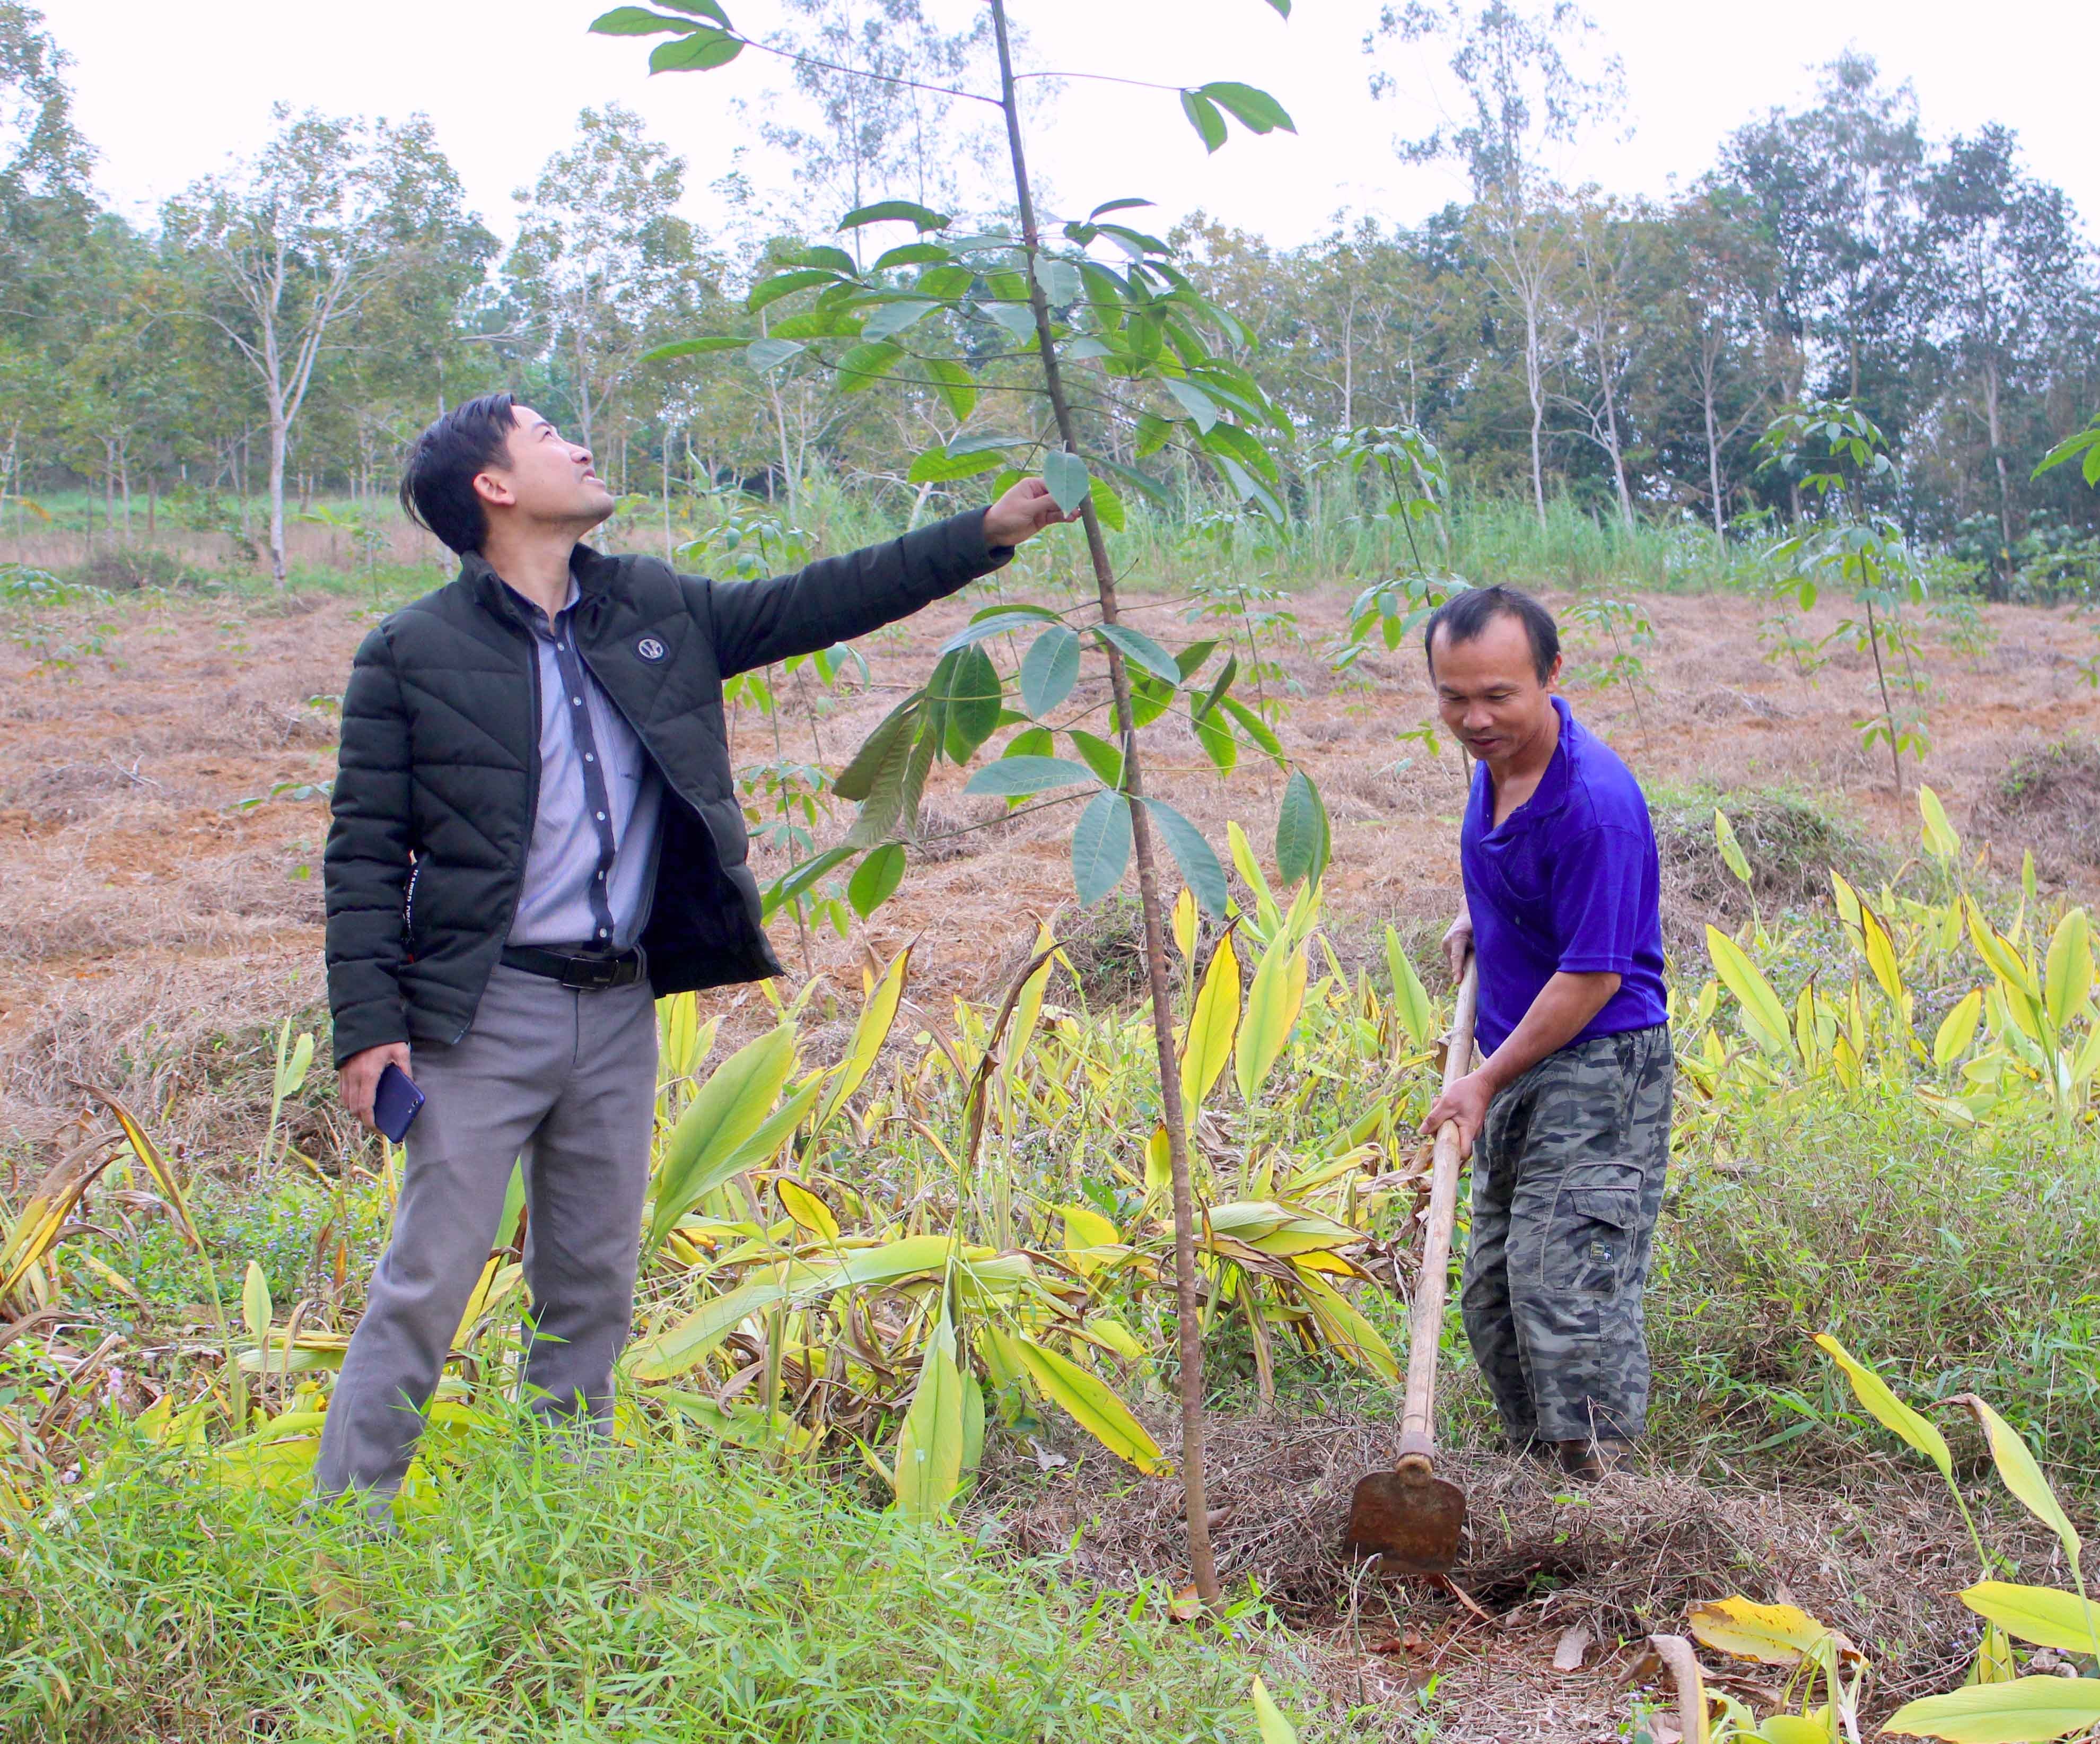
left=1459, top=695, right=1667, bottom=1055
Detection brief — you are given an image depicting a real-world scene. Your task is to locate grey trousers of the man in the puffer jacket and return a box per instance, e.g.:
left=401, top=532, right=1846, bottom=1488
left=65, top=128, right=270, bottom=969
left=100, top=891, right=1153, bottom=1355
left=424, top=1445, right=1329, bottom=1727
left=313, top=964, right=655, bottom=1502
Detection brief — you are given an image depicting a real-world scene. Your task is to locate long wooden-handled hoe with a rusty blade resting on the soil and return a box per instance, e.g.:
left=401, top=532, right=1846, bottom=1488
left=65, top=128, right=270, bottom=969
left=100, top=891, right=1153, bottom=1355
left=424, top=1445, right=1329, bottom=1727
left=1346, top=958, right=1481, bottom=1576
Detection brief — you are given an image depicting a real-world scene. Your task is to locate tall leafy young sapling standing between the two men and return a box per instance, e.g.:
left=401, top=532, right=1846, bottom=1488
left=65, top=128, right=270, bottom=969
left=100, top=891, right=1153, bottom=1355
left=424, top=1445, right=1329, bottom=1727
left=592, top=0, right=1329, bottom=1606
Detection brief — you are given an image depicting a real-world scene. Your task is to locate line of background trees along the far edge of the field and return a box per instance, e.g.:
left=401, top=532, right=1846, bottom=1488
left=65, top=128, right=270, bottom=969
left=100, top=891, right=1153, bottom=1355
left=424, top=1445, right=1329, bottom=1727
left=0, top=0, right=2100, bottom=590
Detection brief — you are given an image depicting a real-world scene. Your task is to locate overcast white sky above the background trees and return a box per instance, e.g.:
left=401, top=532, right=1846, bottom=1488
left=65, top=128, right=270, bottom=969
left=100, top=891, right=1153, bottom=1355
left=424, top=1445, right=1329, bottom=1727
left=42, top=0, right=2100, bottom=244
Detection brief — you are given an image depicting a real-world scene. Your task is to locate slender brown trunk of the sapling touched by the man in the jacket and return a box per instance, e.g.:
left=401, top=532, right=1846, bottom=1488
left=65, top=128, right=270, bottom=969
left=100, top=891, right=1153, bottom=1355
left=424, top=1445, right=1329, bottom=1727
left=991, top=0, right=1220, bottom=1608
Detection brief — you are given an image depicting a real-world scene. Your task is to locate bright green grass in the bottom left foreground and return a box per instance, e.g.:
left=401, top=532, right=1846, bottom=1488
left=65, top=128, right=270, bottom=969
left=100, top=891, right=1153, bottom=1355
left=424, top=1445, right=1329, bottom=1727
left=0, top=1440, right=1256, bottom=1744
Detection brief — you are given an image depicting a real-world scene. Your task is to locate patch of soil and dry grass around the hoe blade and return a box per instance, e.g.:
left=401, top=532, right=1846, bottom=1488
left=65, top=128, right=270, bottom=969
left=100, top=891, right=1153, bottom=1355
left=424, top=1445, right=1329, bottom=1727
left=978, top=1414, right=2064, bottom=1744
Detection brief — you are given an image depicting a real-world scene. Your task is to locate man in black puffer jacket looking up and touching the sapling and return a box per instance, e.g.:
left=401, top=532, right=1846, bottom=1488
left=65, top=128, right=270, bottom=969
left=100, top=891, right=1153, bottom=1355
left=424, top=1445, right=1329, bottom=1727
left=315, top=395, right=1069, bottom=1519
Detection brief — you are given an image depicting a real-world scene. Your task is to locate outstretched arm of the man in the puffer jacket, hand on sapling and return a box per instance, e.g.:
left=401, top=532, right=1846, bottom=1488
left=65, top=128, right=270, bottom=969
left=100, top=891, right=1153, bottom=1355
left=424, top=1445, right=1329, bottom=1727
left=693, top=479, right=1075, bottom=679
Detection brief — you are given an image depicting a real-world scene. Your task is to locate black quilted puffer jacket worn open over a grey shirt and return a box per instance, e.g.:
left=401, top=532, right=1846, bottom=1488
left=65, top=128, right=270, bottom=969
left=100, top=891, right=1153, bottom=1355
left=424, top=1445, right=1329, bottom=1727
left=326, top=509, right=1012, bottom=1063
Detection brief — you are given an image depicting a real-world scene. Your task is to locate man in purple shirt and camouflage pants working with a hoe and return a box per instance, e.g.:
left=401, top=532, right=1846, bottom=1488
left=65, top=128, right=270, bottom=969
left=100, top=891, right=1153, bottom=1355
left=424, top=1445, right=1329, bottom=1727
left=1424, top=586, right=1676, bottom=1477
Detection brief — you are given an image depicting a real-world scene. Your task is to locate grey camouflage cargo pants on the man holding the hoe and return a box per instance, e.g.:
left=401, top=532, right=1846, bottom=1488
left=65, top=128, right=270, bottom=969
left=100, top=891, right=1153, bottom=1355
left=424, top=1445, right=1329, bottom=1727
left=1462, top=1023, right=1676, bottom=1445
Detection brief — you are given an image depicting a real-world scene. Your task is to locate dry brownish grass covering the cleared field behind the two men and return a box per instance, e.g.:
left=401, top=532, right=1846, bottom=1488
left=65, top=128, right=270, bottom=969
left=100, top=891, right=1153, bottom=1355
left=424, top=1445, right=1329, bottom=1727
left=0, top=580, right=2100, bottom=1147
